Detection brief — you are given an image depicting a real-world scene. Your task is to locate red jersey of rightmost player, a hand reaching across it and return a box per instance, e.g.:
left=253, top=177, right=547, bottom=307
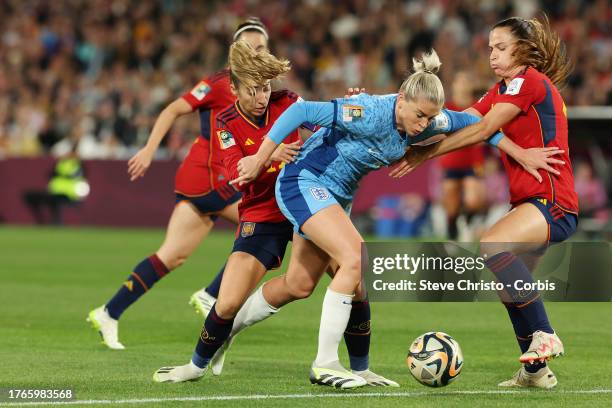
left=473, top=67, right=578, bottom=213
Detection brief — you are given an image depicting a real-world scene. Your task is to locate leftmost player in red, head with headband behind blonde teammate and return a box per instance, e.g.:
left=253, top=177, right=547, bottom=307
left=87, top=18, right=268, bottom=350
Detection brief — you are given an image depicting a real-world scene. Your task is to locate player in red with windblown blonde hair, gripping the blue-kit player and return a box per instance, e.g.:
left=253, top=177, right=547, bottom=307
left=153, top=41, right=300, bottom=382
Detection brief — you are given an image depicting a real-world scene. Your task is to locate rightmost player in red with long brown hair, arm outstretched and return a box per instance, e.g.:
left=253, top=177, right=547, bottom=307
left=392, top=17, right=578, bottom=388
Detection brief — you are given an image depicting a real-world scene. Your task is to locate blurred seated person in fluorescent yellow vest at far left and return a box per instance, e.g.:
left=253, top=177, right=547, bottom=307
left=23, top=149, right=89, bottom=225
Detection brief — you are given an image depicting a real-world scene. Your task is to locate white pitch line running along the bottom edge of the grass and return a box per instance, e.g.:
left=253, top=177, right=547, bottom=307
left=0, top=389, right=612, bottom=407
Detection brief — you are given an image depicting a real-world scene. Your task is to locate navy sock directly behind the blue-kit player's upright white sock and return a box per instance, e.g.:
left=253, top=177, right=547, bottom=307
left=344, top=299, right=371, bottom=371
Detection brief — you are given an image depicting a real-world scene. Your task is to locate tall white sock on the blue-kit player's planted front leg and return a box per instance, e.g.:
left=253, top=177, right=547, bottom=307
left=315, top=288, right=353, bottom=367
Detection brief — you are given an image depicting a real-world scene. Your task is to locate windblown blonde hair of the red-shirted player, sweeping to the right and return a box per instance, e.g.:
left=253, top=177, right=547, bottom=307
left=229, top=41, right=291, bottom=90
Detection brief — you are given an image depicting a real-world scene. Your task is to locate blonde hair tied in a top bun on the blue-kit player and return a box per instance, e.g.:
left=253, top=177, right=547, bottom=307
left=399, top=49, right=444, bottom=107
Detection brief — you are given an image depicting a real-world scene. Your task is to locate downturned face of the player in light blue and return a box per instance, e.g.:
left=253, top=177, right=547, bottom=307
left=395, top=93, right=440, bottom=136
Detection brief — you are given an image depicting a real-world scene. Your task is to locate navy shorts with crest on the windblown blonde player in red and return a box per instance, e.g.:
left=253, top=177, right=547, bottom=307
left=232, top=221, right=293, bottom=270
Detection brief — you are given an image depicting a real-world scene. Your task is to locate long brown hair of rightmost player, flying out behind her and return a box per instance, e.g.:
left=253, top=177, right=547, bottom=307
left=493, top=14, right=573, bottom=88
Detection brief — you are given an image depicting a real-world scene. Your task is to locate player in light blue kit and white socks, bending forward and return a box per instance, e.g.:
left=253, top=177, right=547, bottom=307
left=232, top=47, right=560, bottom=388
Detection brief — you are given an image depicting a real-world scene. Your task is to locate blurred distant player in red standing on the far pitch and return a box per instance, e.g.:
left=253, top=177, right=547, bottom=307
left=438, top=71, right=485, bottom=241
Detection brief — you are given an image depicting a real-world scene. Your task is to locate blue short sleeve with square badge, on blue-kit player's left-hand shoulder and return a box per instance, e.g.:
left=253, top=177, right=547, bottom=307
left=332, top=94, right=384, bottom=136
